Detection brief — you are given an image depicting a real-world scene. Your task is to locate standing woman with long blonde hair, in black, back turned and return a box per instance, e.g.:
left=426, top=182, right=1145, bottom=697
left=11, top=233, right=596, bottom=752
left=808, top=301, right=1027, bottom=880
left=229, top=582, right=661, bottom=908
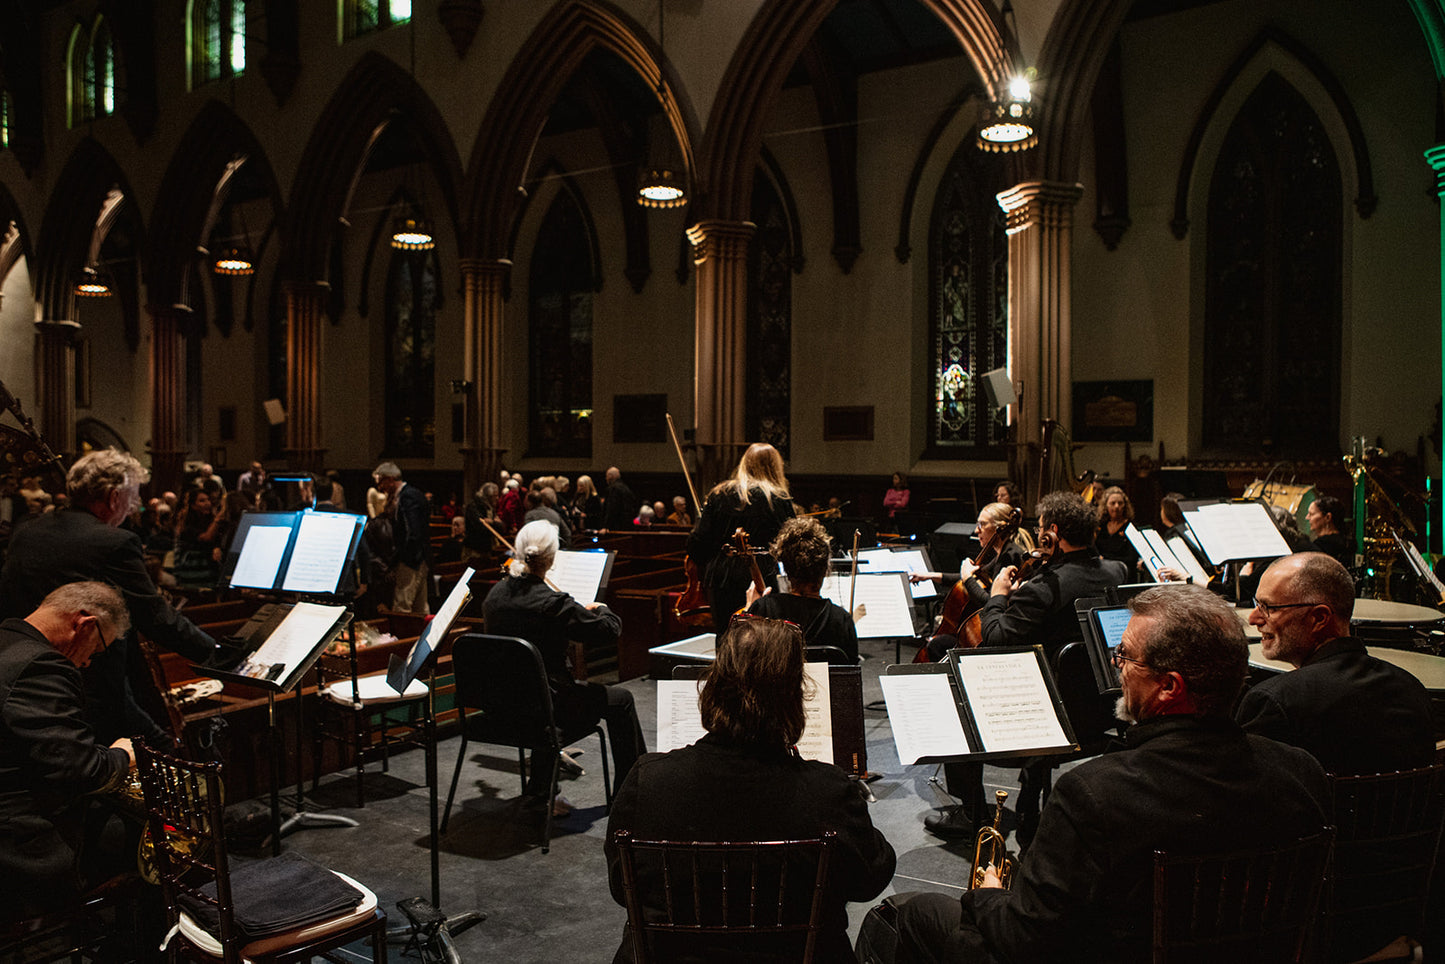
left=688, top=442, right=795, bottom=636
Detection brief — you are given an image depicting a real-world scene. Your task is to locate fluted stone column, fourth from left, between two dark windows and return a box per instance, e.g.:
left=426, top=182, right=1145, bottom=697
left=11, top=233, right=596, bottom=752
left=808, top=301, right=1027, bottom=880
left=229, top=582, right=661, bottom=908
left=461, top=257, right=512, bottom=499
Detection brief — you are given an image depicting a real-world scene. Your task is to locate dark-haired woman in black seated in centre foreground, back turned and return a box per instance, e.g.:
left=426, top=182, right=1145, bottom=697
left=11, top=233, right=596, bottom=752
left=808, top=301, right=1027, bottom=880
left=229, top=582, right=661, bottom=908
left=605, top=619, right=894, bottom=961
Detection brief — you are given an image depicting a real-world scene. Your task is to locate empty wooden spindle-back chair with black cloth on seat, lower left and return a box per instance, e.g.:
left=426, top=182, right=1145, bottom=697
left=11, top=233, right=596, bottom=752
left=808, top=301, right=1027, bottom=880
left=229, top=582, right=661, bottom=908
left=136, top=744, right=386, bottom=964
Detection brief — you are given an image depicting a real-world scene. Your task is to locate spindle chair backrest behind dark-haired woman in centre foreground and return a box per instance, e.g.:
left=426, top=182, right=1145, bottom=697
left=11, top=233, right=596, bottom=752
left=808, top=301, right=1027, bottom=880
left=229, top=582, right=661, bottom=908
left=613, top=831, right=837, bottom=964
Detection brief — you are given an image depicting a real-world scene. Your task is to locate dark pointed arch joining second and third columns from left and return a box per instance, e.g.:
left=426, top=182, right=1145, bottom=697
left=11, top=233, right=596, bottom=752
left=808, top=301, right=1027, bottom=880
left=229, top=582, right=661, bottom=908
left=145, top=100, right=280, bottom=305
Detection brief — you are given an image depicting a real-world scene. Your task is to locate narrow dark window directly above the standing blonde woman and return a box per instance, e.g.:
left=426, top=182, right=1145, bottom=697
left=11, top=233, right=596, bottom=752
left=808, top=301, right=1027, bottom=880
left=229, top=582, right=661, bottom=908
left=746, top=173, right=793, bottom=458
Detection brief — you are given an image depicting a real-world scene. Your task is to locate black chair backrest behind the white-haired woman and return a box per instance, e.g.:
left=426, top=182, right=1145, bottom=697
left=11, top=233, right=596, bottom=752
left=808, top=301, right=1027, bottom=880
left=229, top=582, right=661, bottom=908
left=452, top=633, right=559, bottom=750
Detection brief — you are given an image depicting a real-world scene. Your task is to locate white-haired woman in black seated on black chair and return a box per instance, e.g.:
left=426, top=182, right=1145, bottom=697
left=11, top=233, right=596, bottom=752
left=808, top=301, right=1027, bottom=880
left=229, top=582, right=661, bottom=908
left=481, top=519, right=647, bottom=814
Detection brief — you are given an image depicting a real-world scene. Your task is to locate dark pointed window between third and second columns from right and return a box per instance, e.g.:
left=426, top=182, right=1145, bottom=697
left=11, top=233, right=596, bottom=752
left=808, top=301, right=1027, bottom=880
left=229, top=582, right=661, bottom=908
left=527, top=188, right=597, bottom=458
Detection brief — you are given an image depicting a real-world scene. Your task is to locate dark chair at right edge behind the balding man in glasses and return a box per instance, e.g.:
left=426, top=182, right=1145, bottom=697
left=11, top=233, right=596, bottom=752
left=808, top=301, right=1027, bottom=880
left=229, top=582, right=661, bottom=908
left=1325, top=765, right=1445, bottom=961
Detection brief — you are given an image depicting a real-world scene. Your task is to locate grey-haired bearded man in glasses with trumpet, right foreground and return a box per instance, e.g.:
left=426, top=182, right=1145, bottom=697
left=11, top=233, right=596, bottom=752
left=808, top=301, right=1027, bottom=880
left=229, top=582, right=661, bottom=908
left=894, top=585, right=1329, bottom=964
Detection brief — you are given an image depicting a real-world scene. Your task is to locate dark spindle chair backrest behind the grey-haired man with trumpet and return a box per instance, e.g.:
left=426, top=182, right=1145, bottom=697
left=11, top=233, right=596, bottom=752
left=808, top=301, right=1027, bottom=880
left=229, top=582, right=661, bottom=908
left=1153, top=828, right=1334, bottom=964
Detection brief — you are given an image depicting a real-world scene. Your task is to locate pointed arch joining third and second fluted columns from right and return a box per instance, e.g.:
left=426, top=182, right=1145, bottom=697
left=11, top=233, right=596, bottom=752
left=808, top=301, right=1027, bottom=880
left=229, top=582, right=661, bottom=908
left=464, top=0, right=702, bottom=260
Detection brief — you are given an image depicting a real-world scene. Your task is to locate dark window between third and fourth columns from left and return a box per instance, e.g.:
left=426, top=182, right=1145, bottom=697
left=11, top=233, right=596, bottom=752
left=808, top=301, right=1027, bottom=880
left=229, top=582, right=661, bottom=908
left=386, top=250, right=442, bottom=458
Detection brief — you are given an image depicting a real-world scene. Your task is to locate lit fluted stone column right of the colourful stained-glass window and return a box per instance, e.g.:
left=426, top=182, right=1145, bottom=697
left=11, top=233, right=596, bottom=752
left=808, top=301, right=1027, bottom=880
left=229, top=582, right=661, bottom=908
left=998, top=181, right=1084, bottom=504
